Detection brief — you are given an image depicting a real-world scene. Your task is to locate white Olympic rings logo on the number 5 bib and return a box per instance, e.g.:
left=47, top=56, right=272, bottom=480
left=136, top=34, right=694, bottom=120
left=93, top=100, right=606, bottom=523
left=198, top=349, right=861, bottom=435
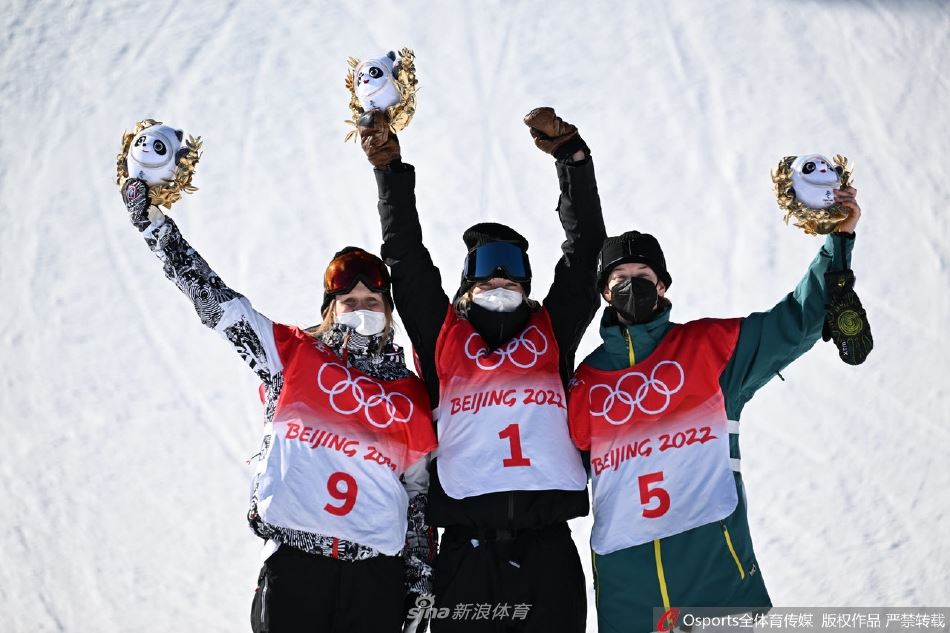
left=588, top=360, right=686, bottom=426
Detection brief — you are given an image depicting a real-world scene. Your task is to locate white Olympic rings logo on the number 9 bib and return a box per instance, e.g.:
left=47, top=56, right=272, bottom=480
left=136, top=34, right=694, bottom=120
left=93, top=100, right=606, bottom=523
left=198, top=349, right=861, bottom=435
left=317, top=363, right=413, bottom=429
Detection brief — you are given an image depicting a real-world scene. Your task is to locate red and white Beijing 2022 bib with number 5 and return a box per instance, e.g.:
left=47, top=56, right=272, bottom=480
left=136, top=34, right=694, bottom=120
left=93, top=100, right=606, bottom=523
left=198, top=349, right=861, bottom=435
left=570, top=319, right=740, bottom=554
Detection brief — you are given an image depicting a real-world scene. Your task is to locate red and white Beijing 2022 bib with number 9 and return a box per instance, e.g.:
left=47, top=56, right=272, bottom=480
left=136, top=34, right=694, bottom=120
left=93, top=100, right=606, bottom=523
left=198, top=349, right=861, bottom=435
left=257, top=324, right=436, bottom=555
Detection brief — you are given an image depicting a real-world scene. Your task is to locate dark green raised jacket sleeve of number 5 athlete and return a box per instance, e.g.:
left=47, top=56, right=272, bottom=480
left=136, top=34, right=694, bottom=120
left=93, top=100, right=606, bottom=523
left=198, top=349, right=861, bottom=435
left=719, top=233, right=854, bottom=420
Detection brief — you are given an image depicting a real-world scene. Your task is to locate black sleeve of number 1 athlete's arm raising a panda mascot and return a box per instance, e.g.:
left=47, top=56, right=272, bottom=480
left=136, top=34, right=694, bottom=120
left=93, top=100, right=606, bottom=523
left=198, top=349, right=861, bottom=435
left=375, top=163, right=449, bottom=407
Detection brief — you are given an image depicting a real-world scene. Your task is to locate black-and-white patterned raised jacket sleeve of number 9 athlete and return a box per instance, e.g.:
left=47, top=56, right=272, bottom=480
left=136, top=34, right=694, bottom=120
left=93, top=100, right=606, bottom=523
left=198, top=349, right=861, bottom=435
left=142, top=207, right=283, bottom=387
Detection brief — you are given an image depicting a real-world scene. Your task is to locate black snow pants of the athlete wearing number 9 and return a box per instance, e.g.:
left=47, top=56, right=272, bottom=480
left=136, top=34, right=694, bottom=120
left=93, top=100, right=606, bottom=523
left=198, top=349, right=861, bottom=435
left=251, top=545, right=406, bottom=633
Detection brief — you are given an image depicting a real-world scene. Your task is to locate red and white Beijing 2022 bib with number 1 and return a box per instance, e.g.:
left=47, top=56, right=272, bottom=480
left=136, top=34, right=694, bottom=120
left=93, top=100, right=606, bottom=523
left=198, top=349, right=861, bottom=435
left=436, top=307, right=587, bottom=499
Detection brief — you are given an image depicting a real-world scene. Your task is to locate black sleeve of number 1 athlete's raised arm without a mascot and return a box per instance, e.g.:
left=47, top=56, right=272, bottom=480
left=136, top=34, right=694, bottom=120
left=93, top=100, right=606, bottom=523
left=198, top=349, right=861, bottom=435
left=544, top=157, right=607, bottom=385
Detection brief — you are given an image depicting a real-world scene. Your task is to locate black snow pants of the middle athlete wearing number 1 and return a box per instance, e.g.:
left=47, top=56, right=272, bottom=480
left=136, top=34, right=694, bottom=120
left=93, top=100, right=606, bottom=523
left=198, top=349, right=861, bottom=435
left=430, top=523, right=587, bottom=633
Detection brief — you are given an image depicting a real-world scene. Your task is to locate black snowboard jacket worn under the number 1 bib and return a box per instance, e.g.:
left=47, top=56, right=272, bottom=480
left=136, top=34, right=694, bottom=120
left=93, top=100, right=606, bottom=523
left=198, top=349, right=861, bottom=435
left=375, top=157, right=606, bottom=531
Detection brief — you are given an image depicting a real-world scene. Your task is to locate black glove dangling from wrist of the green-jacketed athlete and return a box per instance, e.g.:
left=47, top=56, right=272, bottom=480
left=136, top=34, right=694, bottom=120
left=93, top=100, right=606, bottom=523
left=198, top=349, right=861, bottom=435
left=821, top=270, right=874, bottom=365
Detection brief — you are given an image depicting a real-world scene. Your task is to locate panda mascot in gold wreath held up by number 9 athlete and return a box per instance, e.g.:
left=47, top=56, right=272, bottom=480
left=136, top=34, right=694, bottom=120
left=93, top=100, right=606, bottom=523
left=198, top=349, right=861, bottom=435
left=115, top=119, right=201, bottom=209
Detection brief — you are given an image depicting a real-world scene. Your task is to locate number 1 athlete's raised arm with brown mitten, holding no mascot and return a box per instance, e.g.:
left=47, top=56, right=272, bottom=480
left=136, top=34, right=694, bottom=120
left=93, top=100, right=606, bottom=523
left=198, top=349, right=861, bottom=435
left=525, top=108, right=607, bottom=384
